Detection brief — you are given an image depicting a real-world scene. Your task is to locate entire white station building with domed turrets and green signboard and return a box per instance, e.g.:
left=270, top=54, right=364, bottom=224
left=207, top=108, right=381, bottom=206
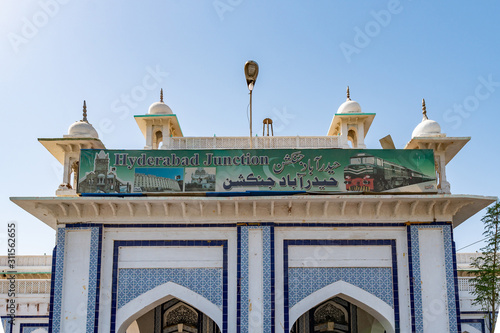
left=2, top=88, right=496, bottom=333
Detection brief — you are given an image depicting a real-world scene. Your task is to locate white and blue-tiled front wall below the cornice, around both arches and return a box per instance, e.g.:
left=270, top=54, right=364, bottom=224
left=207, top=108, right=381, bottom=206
left=44, top=218, right=459, bottom=332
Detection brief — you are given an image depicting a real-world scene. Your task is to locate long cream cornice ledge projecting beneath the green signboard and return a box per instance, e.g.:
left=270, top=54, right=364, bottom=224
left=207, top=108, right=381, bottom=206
left=11, top=194, right=496, bottom=229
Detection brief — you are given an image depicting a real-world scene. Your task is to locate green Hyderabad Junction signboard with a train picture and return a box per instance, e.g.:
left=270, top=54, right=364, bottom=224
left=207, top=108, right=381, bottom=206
left=78, top=149, right=437, bottom=194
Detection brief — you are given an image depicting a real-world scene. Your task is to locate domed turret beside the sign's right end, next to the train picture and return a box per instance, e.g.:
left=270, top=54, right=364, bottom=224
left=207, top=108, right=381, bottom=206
left=405, top=99, right=470, bottom=193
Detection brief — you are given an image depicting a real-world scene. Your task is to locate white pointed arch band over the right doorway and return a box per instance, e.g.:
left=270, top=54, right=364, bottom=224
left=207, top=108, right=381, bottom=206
left=290, top=281, right=395, bottom=333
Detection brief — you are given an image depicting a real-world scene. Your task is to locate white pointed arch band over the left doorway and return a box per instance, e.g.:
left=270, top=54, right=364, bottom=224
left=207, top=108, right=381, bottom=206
left=116, top=282, right=222, bottom=333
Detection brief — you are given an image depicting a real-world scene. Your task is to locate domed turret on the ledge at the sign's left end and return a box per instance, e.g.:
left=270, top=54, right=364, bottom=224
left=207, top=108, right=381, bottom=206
left=38, top=101, right=106, bottom=196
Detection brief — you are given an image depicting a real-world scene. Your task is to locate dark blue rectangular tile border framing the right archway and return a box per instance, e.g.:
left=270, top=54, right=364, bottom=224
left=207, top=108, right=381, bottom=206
left=283, top=239, right=400, bottom=332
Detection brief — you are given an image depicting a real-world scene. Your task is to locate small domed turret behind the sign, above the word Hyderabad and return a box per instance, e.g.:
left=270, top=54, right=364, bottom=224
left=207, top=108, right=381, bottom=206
left=134, top=89, right=183, bottom=149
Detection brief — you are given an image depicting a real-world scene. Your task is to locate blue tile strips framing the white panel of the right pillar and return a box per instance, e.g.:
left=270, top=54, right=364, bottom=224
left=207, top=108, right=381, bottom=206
left=408, top=224, right=458, bottom=333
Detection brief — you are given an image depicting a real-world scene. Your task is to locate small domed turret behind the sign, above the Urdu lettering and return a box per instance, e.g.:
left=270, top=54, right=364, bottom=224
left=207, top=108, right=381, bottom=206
left=327, top=86, right=375, bottom=148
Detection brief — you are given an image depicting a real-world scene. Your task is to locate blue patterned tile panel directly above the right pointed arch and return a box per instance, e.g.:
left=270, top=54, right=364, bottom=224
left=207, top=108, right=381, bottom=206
left=288, top=267, right=394, bottom=308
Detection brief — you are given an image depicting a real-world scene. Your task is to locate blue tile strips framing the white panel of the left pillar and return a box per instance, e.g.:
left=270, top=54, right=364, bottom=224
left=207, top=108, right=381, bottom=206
left=49, top=226, right=102, bottom=333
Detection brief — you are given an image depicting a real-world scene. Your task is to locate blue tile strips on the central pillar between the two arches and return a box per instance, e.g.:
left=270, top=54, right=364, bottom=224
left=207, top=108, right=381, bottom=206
left=237, top=225, right=275, bottom=333
